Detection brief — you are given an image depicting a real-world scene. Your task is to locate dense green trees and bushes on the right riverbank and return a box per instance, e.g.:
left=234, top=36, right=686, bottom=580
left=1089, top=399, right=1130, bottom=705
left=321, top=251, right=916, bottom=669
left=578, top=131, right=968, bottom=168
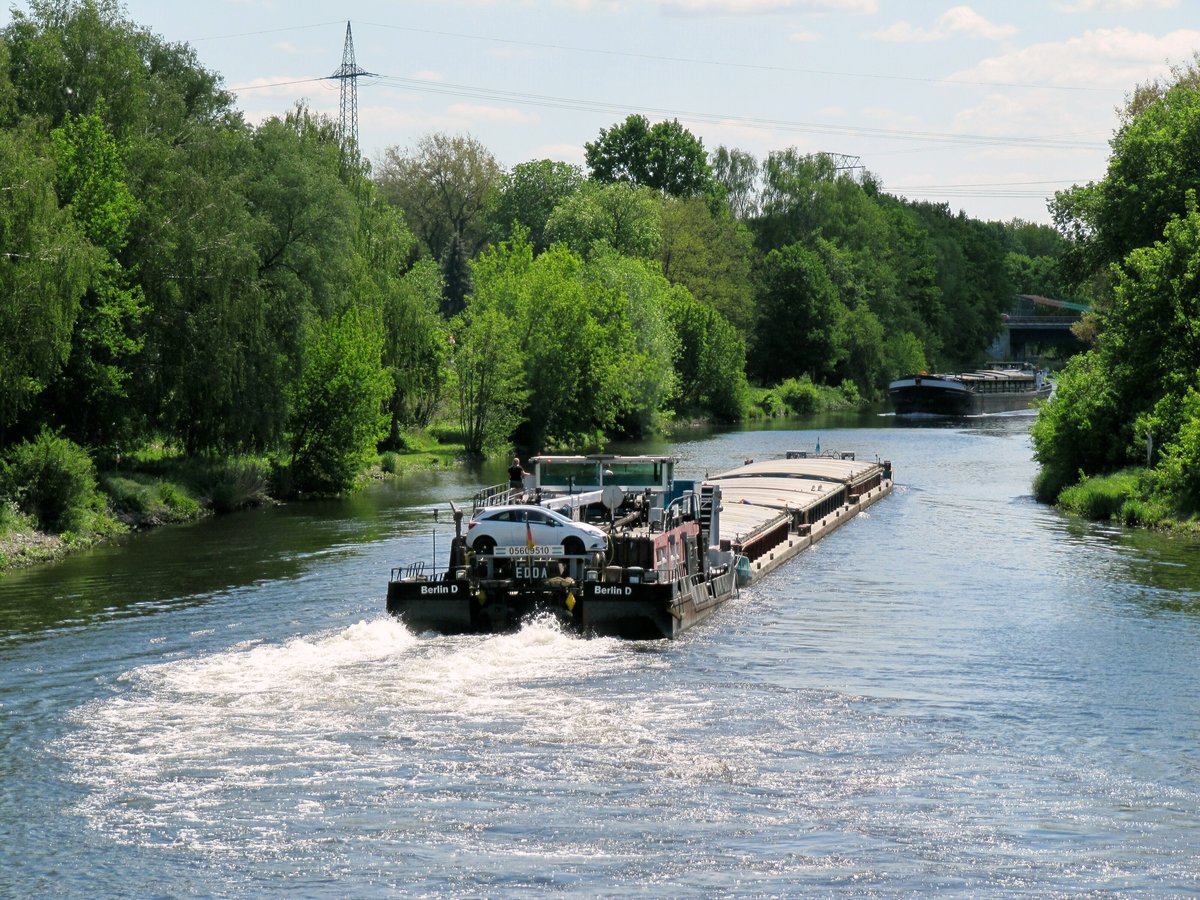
left=1033, top=56, right=1200, bottom=527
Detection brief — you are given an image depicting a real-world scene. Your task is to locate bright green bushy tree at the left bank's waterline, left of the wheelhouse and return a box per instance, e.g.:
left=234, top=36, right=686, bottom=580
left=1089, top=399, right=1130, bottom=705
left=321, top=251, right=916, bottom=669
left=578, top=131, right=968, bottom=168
left=290, top=310, right=391, bottom=493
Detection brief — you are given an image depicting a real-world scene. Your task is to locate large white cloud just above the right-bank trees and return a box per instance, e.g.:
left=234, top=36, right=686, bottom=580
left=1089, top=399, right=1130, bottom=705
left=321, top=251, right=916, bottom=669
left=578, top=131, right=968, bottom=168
left=950, top=28, right=1200, bottom=90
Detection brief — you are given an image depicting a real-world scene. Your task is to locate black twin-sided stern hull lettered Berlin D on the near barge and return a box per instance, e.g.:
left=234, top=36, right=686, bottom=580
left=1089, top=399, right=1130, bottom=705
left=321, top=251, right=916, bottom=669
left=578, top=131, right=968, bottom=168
left=388, top=569, right=737, bottom=640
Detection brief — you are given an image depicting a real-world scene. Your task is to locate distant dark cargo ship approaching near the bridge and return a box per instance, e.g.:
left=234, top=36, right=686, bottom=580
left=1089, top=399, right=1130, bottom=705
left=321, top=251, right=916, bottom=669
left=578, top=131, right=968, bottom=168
left=888, top=362, right=1054, bottom=415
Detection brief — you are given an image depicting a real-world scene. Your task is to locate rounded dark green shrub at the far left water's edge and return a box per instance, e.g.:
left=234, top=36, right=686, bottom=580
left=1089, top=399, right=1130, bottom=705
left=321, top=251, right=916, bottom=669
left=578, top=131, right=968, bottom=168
left=4, top=431, right=106, bottom=534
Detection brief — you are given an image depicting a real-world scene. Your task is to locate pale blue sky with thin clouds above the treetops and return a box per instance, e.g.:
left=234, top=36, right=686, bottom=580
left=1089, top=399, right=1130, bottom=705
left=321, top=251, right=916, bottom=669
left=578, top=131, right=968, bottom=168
left=6, top=0, right=1200, bottom=223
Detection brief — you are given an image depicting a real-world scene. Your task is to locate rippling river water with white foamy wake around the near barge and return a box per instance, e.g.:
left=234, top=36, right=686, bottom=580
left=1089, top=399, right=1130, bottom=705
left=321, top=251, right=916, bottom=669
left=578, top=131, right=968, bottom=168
left=0, top=415, right=1200, bottom=898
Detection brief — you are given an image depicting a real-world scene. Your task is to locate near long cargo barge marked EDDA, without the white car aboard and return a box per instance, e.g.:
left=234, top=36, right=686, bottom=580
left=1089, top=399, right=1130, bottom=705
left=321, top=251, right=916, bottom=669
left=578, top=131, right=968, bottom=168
left=388, top=452, right=892, bottom=638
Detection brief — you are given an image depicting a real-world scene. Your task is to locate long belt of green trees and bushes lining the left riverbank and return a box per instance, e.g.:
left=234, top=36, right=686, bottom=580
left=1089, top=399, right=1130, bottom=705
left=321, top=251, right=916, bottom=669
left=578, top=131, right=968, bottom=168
left=0, top=0, right=1063, bottom=571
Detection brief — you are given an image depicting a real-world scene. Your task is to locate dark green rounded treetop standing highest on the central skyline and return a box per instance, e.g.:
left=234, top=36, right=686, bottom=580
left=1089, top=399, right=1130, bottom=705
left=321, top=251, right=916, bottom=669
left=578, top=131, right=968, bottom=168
left=583, top=115, right=714, bottom=197
